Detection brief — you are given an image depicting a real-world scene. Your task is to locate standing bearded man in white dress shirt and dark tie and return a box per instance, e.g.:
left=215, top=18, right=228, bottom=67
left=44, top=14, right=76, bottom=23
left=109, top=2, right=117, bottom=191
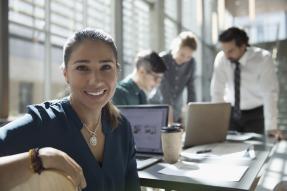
left=211, top=27, right=279, bottom=134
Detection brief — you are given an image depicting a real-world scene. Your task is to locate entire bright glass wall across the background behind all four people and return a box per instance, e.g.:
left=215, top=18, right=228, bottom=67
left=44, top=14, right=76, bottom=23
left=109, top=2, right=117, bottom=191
left=6, top=0, right=287, bottom=118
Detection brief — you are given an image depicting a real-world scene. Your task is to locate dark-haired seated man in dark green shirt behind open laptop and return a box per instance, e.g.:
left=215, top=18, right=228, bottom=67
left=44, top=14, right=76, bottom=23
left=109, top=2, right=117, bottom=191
left=113, top=51, right=166, bottom=105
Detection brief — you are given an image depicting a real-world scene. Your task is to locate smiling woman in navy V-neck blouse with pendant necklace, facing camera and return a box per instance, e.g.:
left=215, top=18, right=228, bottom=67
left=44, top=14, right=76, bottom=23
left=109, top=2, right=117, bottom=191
left=0, top=29, right=139, bottom=191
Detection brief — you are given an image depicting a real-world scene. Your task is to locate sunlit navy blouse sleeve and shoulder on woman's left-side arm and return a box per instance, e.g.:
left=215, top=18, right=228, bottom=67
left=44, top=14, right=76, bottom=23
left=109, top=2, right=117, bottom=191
left=0, top=100, right=69, bottom=156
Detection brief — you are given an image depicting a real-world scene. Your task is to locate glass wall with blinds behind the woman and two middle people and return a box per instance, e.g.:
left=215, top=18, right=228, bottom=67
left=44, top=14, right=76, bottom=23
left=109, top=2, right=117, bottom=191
left=6, top=0, right=217, bottom=115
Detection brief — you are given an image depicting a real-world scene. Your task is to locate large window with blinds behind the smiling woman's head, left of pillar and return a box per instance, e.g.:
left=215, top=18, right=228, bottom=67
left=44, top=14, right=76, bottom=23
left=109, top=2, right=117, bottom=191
left=9, top=0, right=112, bottom=115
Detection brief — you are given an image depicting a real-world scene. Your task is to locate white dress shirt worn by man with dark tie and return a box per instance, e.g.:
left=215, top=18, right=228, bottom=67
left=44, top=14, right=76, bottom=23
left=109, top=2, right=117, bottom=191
left=210, top=47, right=279, bottom=130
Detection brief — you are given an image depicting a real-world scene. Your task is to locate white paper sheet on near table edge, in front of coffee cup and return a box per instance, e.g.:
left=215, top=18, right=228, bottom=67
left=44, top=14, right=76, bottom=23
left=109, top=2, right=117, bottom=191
left=158, top=161, right=248, bottom=181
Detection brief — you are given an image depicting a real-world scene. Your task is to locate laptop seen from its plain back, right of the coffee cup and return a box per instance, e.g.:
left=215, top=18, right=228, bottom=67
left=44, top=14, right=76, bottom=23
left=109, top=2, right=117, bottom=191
left=183, top=102, right=231, bottom=148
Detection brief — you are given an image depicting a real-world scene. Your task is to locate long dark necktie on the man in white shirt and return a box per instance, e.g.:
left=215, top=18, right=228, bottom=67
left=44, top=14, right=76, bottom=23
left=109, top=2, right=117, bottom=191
left=233, top=61, right=241, bottom=120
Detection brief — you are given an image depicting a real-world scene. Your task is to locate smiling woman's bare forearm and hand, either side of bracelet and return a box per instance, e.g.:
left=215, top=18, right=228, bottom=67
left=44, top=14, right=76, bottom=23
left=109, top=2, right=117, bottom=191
left=0, top=148, right=86, bottom=190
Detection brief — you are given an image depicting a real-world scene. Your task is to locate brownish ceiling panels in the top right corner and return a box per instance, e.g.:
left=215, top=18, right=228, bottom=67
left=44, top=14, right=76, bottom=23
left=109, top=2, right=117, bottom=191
left=225, top=0, right=287, bottom=17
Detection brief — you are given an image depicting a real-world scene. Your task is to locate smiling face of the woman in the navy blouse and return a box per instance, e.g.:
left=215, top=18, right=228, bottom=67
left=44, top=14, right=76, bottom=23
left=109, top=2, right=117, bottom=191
left=64, top=40, right=117, bottom=110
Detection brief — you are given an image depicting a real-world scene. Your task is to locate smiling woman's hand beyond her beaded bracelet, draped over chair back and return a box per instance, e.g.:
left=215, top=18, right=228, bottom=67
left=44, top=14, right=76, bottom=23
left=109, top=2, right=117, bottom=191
left=39, top=147, right=87, bottom=188
